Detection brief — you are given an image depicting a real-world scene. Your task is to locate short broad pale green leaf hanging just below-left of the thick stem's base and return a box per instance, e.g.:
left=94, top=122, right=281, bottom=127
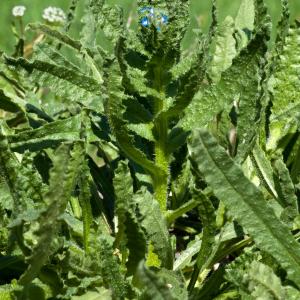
left=134, top=189, right=173, bottom=269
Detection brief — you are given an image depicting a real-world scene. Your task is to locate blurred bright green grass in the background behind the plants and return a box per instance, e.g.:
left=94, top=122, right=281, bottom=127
left=0, top=0, right=300, bottom=51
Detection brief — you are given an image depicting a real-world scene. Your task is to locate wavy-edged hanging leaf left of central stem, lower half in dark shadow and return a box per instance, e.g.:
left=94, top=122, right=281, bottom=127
left=114, top=161, right=147, bottom=274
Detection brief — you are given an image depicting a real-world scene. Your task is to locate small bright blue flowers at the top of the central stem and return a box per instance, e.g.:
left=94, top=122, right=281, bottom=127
left=139, top=7, right=168, bottom=31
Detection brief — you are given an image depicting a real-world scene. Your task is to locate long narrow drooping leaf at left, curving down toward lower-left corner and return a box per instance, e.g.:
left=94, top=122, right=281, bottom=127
left=19, top=144, right=83, bottom=285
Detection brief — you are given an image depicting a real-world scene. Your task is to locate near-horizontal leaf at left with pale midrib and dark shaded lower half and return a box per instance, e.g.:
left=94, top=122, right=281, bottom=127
left=8, top=115, right=81, bottom=152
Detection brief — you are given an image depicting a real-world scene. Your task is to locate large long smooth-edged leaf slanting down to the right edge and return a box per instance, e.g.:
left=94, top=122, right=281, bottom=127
left=190, top=130, right=300, bottom=286
